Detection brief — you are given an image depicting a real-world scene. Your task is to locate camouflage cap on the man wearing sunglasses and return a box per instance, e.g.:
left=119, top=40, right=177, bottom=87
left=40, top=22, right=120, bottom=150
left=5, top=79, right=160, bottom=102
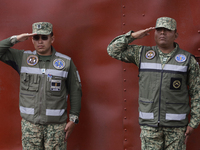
left=32, top=22, right=53, bottom=35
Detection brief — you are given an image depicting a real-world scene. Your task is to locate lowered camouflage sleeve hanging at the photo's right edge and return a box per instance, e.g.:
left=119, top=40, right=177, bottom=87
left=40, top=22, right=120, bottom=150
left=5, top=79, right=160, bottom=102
left=188, top=56, right=200, bottom=128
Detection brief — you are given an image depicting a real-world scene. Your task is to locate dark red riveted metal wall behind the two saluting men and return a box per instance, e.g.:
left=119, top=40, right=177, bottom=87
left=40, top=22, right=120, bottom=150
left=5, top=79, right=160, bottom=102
left=0, top=0, right=200, bottom=150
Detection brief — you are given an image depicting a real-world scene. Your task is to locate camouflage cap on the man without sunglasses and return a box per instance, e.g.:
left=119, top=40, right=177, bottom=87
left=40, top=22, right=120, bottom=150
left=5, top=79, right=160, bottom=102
left=155, top=17, right=176, bottom=31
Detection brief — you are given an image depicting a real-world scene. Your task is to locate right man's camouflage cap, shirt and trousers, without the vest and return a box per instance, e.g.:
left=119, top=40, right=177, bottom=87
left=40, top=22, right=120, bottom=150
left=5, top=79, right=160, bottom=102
left=107, top=18, right=200, bottom=150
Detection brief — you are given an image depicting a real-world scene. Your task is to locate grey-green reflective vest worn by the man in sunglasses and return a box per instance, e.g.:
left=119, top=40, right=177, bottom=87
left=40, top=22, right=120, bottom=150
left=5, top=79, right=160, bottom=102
left=19, top=49, right=71, bottom=124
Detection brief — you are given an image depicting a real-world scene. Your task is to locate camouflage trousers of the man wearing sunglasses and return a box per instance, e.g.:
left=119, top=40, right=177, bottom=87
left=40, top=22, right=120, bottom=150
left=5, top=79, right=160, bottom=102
left=21, top=119, right=67, bottom=150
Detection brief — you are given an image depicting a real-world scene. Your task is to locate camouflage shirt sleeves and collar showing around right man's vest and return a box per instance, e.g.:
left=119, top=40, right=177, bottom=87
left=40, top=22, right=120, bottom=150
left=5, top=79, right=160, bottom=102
left=107, top=31, right=200, bottom=128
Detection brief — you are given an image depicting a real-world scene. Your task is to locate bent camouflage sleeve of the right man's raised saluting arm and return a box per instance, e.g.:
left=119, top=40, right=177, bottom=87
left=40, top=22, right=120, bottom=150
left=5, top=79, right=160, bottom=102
left=107, top=31, right=142, bottom=66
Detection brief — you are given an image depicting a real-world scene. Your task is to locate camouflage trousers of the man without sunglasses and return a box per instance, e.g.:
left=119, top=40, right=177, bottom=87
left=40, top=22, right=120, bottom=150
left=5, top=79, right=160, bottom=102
left=140, top=126, right=186, bottom=150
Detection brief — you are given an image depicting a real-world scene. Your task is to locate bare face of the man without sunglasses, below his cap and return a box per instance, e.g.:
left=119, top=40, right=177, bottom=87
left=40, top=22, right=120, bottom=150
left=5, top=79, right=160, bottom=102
left=154, top=28, right=178, bottom=48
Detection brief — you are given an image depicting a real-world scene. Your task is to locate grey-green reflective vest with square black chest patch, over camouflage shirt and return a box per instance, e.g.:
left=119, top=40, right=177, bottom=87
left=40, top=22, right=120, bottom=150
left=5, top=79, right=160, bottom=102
left=139, top=47, right=191, bottom=127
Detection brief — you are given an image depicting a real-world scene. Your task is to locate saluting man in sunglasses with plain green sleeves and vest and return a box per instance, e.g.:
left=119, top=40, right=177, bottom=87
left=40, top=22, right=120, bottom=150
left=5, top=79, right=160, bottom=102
left=0, top=22, right=82, bottom=150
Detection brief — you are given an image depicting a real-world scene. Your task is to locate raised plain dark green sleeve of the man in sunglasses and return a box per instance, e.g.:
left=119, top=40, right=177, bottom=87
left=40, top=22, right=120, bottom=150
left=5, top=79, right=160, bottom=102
left=0, top=37, right=23, bottom=73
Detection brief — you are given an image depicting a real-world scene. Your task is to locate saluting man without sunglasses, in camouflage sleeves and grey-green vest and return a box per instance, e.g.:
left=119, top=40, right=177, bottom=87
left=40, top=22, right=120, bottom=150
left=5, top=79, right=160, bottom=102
left=107, top=17, right=200, bottom=150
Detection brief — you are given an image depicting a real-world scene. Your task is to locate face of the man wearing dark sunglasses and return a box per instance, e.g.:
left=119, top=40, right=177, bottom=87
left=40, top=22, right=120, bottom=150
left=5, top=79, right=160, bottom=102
left=32, top=35, right=54, bottom=55
